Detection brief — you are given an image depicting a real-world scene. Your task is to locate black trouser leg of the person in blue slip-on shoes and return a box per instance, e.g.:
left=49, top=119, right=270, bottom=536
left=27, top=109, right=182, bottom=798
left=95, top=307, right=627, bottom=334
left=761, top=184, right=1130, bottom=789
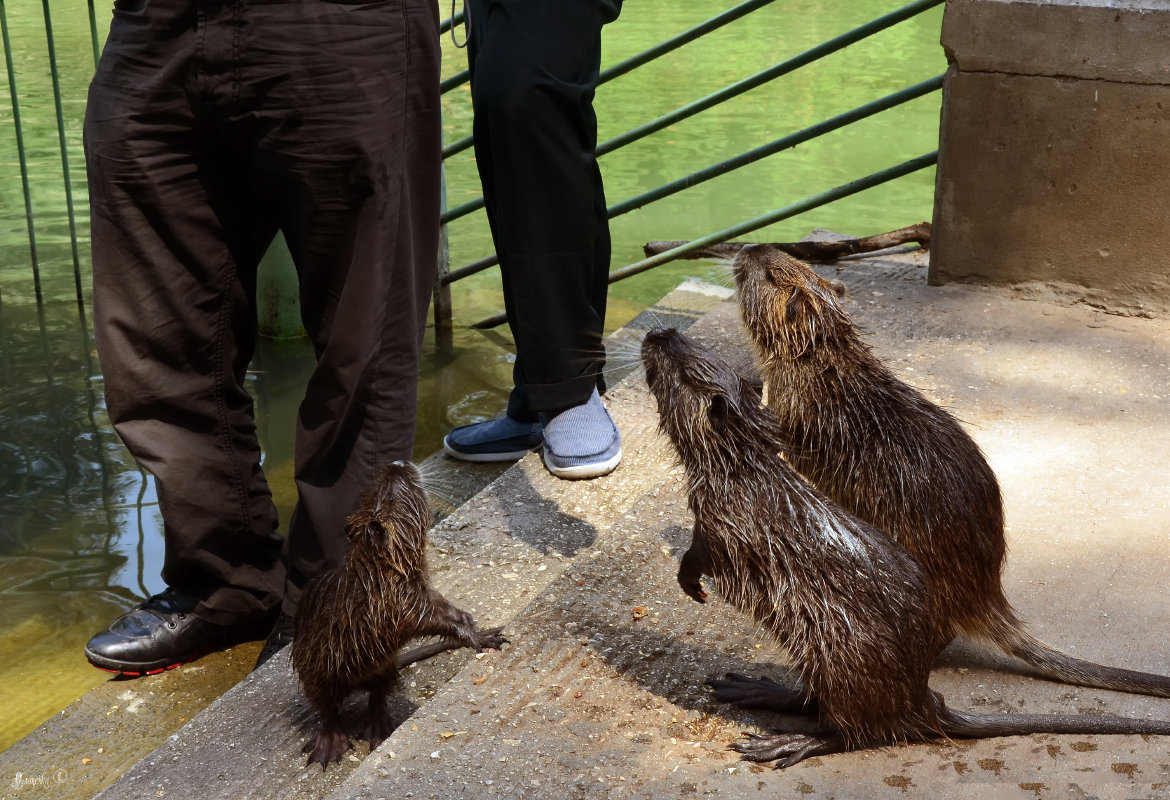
left=468, top=0, right=621, bottom=420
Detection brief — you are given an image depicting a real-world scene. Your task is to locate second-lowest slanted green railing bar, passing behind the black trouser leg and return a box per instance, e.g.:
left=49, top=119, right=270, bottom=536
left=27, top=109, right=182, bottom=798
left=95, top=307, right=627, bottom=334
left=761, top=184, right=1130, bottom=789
left=443, top=75, right=943, bottom=284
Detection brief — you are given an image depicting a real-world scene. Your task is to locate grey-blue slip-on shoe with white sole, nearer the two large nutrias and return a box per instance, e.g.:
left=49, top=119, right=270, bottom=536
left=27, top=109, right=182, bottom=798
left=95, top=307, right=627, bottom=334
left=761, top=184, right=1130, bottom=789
left=541, top=389, right=621, bottom=480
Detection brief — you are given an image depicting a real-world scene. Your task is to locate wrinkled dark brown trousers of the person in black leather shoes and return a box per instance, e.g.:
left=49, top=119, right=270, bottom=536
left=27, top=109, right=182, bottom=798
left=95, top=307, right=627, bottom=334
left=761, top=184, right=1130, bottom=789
left=84, top=0, right=440, bottom=623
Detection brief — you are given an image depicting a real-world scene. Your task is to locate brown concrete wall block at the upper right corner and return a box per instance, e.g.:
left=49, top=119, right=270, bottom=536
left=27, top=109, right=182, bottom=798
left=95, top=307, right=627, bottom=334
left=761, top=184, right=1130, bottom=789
left=930, top=0, right=1170, bottom=315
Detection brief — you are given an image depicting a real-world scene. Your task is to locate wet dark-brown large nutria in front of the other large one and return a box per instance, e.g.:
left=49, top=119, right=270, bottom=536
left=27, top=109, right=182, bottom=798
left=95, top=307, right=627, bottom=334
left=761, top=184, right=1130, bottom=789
left=642, top=329, right=1170, bottom=766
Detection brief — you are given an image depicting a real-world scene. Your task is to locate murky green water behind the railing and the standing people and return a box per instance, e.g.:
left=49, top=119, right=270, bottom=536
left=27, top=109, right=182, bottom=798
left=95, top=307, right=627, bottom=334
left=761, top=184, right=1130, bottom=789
left=0, top=0, right=945, bottom=750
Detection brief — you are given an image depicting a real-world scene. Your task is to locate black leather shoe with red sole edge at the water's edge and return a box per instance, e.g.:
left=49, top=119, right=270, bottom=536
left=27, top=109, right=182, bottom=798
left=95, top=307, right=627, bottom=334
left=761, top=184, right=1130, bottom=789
left=85, top=588, right=271, bottom=677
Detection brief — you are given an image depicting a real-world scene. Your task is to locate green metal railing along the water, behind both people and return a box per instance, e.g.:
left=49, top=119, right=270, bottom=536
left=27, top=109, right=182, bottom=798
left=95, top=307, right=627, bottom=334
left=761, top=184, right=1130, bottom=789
left=0, top=0, right=943, bottom=329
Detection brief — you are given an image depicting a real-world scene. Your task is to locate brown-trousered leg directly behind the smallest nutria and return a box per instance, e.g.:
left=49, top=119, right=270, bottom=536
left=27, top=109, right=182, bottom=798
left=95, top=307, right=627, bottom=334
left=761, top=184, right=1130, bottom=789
left=230, top=0, right=440, bottom=615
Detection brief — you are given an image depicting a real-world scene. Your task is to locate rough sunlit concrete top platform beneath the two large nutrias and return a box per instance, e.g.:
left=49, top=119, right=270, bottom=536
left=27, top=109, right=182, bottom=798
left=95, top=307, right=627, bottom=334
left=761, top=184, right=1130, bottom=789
left=330, top=250, right=1170, bottom=800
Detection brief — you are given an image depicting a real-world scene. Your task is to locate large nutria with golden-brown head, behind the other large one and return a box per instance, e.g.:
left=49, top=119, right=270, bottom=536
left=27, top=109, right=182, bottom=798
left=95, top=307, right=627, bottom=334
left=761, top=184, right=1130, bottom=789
left=734, top=246, right=1170, bottom=697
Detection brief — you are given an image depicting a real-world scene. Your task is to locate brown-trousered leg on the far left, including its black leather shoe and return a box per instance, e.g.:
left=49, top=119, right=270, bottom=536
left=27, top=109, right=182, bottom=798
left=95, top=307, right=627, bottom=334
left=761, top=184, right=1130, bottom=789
left=85, top=5, right=283, bottom=671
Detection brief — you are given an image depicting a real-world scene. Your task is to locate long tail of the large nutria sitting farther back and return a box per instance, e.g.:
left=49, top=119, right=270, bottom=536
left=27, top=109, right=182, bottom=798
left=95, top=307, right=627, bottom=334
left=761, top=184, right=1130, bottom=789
left=983, top=612, right=1170, bottom=697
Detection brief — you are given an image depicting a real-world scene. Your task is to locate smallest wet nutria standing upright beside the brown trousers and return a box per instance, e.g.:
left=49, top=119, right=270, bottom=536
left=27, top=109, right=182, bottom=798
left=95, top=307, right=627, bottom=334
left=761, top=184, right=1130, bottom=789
left=293, top=461, right=507, bottom=768
